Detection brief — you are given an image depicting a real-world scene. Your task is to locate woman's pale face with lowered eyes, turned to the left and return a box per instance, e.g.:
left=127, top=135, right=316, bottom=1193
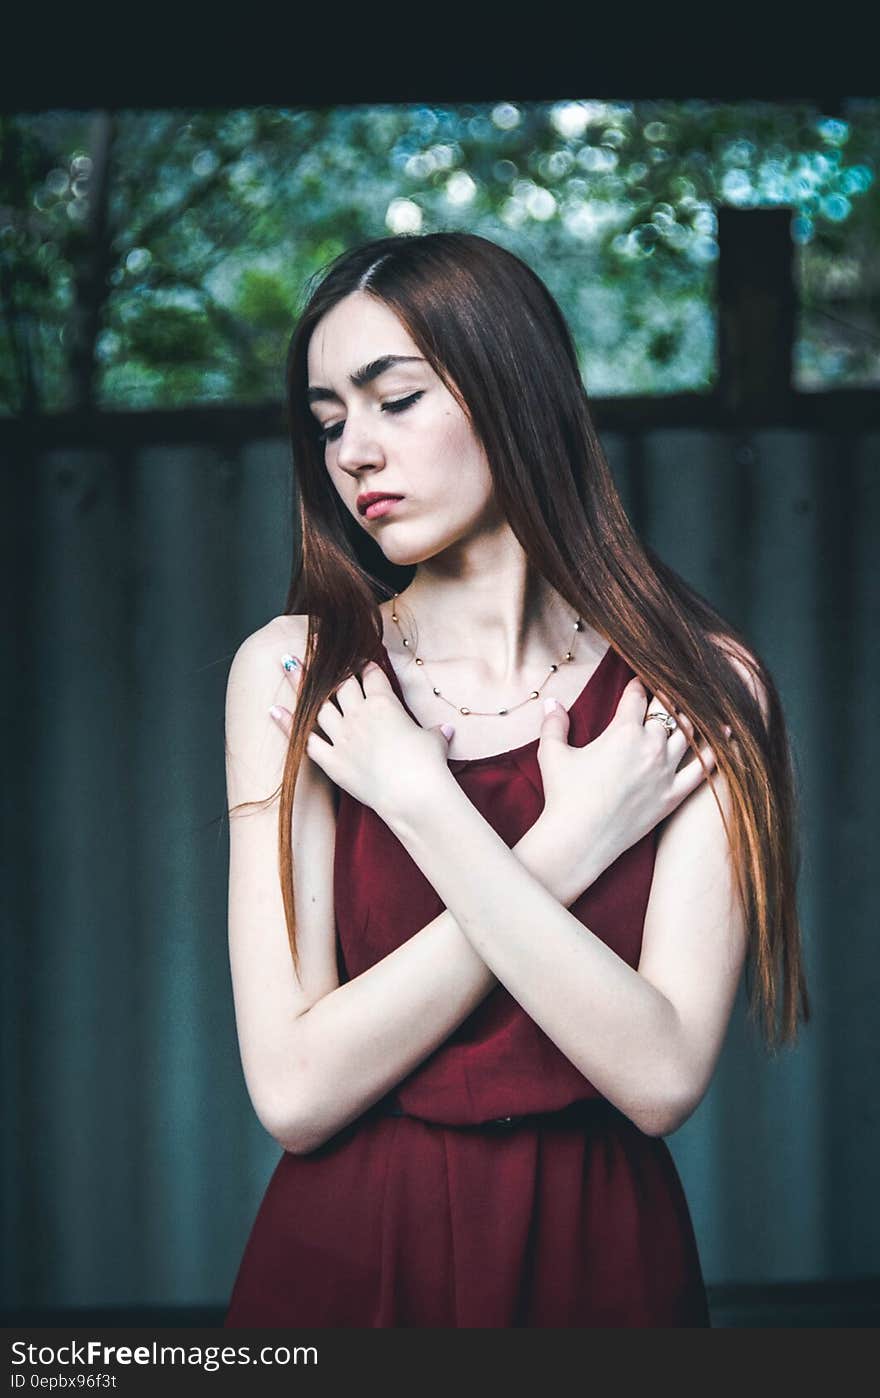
left=308, top=291, right=502, bottom=565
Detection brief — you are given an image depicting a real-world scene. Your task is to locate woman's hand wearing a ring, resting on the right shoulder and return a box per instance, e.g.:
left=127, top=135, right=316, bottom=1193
left=537, top=677, right=715, bottom=877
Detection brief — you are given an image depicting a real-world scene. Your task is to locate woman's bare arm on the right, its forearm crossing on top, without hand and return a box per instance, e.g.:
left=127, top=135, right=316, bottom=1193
left=380, top=659, right=760, bottom=1135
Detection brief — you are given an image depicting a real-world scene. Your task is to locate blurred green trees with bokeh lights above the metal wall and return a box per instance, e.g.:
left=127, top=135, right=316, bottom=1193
left=0, top=101, right=880, bottom=414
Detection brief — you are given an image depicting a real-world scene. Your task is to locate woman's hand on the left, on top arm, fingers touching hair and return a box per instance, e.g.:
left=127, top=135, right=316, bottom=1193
left=273, top=656, right=453, bottom=823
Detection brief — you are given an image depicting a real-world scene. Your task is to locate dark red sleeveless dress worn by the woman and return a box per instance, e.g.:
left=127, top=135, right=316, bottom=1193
left=225, top=650, right=709, bottom=1328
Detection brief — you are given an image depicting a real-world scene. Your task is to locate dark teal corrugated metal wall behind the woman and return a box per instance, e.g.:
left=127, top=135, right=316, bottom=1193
left=0, top=429, right=880, bottom=1306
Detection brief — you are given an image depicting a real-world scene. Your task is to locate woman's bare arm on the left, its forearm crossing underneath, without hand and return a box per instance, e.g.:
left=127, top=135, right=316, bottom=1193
left=227, top=617, right=610, bottom=1153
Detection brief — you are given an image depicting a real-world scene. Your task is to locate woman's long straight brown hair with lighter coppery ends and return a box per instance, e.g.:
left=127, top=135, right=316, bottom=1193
left=237, top=232, right=810, bottom=1051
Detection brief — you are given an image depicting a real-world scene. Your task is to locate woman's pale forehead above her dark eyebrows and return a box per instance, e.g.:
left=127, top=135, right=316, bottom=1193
left=308, top=291, right=421, bottom=386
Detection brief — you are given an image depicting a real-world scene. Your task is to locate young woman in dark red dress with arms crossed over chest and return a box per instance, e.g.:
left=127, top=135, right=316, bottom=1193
left=225, top=233, right=809, bottom=1328
